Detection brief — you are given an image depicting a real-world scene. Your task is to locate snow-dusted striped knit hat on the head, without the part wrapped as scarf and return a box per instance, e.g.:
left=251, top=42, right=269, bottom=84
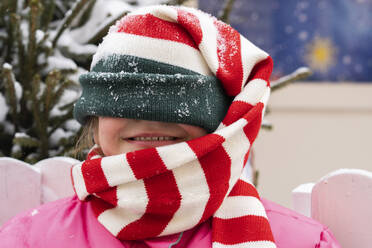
left=74, top=6, right=272, bottom=132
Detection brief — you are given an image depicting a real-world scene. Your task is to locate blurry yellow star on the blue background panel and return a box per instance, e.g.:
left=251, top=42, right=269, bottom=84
left=305, top=36, right=337, bottom=73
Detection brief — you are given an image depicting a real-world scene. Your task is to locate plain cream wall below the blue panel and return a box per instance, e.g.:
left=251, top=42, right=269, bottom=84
left=254, top=83, right=372, bottom=207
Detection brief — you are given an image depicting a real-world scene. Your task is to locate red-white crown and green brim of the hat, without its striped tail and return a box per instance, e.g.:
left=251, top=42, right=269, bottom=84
left=74, top=6, right=237, bottom=132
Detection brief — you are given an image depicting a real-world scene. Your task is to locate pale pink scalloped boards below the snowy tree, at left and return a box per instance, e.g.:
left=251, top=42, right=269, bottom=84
left=0, top=157, right=79, bottom=225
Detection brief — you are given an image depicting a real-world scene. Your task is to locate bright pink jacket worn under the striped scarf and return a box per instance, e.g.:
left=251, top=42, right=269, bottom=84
left=0, top=197, right=340, bottom=248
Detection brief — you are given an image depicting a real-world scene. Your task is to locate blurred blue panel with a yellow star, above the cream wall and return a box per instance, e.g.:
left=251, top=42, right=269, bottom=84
left=199, top=0, right=372, bottom=82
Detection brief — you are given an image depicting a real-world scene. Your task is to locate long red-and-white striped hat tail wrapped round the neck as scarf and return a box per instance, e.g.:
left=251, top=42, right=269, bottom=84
left=72, top=6, right=276, bottom=248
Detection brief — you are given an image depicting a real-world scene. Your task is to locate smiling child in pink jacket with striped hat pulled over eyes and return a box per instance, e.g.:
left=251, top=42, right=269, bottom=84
left=0, top=6, right=339, bottom=248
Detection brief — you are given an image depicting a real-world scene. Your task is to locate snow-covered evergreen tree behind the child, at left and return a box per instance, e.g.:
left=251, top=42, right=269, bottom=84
left=0, top=0, right=195, bottom=163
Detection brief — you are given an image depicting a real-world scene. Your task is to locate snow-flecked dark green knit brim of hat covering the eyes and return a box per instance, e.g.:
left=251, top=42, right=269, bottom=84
left=74, top=55, right=232, bottom=132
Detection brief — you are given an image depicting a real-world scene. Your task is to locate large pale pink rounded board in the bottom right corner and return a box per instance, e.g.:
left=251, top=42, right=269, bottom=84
left=311, top=169, right=372, bottom=248
